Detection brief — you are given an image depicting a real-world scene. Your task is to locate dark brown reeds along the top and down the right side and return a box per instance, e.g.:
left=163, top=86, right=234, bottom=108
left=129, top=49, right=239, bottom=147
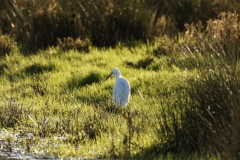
left=0, top=0, right=240, bottom=158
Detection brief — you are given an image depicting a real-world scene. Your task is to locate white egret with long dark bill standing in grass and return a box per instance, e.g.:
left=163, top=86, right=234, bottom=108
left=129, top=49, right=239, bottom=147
left=105, top=68, right=130, bottom=107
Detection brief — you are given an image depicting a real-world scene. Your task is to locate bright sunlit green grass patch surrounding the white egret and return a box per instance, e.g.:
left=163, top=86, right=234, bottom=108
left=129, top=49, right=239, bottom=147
left=0, top=40, right=238, bottom=159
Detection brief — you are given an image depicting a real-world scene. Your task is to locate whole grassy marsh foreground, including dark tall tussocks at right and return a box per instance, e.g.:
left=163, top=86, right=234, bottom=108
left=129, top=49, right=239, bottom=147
left=0, top=20, right=240, bottom=159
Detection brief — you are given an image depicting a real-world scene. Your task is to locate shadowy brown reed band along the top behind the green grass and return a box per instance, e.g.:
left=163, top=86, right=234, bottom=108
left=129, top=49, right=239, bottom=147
left=0, top=0, right=240, bottom=51
